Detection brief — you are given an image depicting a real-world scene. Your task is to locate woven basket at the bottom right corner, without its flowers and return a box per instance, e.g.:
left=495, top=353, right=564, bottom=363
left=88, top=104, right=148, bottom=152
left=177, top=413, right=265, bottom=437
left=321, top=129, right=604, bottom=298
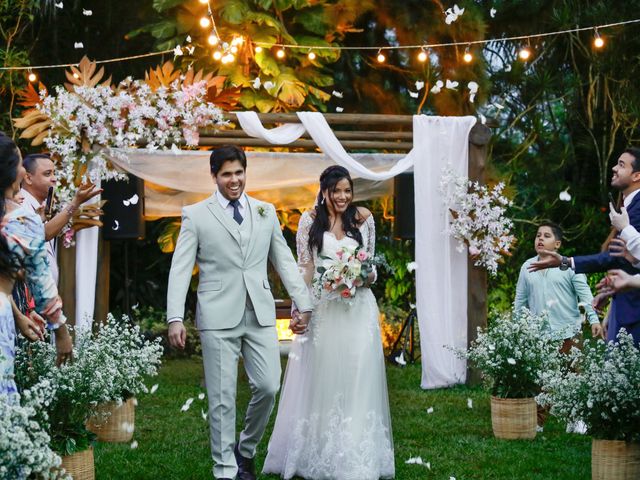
left=591, top=438, right=640, bottom=480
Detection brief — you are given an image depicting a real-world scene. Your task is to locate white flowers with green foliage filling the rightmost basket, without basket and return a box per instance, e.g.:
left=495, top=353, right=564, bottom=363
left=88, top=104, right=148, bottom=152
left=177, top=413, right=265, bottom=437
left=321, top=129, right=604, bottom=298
left=537, top=329, right=640, bottom=442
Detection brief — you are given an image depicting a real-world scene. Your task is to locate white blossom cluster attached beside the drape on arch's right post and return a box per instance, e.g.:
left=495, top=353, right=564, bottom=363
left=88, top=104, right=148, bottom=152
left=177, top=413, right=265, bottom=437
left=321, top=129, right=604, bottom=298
left=440, top=169, right=515, bottom=275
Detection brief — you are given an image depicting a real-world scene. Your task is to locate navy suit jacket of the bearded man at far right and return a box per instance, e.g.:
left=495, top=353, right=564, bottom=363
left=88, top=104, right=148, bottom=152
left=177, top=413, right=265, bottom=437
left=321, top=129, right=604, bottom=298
left=573, top=193, right=640, bottom=334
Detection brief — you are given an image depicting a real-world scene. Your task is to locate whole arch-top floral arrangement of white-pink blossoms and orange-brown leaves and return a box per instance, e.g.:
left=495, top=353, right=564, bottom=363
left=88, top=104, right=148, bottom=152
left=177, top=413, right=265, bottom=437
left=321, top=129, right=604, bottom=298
left=14, top=57, right=238, bottom=246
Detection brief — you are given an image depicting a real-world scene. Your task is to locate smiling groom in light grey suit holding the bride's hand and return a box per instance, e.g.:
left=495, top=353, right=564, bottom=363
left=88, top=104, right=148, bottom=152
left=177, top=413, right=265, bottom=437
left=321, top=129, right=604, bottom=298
left=167, top=146, right=312, bottom=480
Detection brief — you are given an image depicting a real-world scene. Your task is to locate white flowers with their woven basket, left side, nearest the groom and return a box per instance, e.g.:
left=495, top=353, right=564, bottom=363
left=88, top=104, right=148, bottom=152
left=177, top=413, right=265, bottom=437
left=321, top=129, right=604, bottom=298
left=87, top=314, right=163, bottom=442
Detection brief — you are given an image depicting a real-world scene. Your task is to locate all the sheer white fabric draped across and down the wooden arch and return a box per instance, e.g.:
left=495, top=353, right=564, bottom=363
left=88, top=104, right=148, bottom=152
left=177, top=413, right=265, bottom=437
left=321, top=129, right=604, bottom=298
left=76, top=112, right=476, bottom=388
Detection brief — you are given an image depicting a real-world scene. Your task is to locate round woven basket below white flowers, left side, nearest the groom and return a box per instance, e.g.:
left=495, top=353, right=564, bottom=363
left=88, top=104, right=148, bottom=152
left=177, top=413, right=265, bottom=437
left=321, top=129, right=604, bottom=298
left=87, top=398, right=136, bottom=443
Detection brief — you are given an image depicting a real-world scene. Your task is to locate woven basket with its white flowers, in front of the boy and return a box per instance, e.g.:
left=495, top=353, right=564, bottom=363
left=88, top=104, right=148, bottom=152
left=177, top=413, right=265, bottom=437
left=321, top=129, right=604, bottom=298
left=458, top=309, right=560, bottom=439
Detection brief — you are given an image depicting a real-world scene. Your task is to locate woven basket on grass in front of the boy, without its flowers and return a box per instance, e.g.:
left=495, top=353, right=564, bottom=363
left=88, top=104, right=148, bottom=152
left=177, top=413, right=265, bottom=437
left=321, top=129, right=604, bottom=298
left=491, top=397, right=537, bottom=440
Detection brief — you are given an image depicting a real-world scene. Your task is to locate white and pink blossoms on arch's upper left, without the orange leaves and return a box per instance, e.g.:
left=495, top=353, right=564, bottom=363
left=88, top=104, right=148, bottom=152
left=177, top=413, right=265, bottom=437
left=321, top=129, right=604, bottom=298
left=37, top=78, right=224, bottom=244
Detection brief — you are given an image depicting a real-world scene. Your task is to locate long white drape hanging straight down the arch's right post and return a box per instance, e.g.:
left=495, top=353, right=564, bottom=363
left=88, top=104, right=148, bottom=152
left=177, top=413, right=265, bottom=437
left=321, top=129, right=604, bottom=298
left=413, top=116, right=475, bottom=388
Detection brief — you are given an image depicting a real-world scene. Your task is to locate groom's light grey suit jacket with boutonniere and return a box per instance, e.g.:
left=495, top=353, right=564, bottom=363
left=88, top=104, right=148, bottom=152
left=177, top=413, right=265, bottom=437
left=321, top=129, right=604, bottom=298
left=167, top=195, right=312, bottom=330
